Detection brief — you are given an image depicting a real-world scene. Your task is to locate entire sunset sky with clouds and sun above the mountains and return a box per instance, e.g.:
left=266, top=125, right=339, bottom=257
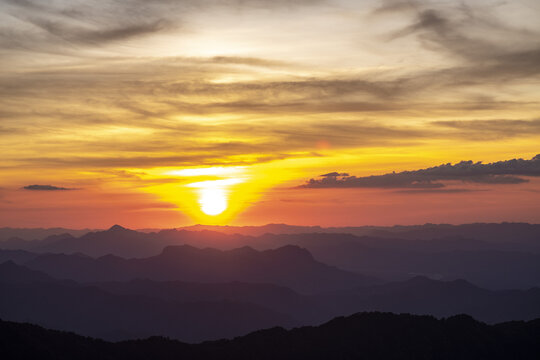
left=0, top=0, right=540, bottom=228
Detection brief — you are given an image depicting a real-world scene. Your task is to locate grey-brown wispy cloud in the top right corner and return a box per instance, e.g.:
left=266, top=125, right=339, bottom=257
left=373, top=1, right=540, bottom=83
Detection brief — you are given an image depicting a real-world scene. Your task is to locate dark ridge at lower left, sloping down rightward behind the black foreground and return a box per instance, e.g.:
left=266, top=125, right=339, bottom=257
left=0, top=263, right=298, bottom=341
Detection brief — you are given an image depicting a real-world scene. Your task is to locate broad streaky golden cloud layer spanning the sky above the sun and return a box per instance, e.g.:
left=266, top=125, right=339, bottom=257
left=0, top=0, right=540, bottom=174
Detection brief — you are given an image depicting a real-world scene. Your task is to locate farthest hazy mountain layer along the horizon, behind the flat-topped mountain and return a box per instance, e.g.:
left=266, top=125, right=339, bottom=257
left=0, top=224, right=540, bottom=289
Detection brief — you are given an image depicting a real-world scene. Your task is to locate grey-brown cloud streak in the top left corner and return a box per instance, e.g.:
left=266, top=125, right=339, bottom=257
left=0, top=0, right=321, bottom=56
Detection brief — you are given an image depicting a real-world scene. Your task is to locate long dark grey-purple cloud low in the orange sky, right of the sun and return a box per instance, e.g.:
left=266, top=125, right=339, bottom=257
left=300, top=154, right=540, bottom=190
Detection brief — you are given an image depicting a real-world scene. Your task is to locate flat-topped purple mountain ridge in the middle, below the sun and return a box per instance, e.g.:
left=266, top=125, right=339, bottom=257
left=25, top=245, right=377, bottom=293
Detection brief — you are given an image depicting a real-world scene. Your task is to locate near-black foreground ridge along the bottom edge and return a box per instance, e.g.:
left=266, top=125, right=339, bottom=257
left=0, top=313, right=540, bottom=360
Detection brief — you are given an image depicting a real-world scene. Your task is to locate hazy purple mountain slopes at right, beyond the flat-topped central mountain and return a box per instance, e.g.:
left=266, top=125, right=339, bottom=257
left=261, top=234, right=540, bottom=289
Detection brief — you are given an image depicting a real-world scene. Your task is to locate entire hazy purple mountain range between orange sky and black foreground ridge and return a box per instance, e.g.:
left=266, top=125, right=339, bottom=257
left=0, top=223, right=540, bottom=346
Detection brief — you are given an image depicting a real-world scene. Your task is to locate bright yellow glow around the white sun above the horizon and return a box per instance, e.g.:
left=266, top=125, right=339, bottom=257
left=139, top=161, right=312, bottom=225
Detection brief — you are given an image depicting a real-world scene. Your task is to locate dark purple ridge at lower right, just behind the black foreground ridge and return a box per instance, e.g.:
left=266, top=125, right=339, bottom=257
left=312, top=277, right=540, bottom=323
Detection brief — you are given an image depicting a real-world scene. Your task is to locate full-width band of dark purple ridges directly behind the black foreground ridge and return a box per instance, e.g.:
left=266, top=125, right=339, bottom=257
left=0, top=262, right=540, bottom=341
